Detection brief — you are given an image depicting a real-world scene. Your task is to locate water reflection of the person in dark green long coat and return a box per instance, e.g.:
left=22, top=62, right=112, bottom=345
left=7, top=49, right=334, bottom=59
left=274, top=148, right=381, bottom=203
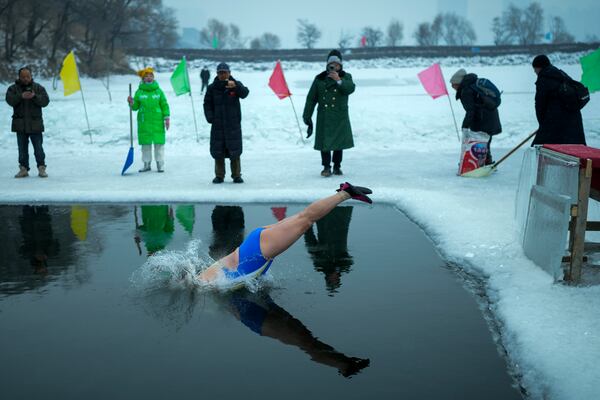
left=304, top=207, right=353, bottom=293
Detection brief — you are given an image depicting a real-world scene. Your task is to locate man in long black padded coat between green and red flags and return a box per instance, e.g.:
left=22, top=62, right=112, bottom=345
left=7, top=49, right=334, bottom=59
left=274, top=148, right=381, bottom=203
left=204, top=63, right=249, bottom=183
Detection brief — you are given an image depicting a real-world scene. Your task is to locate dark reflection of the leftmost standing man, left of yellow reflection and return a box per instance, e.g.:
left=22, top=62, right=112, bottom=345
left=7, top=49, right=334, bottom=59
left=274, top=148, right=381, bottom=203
left=19, top=206, right=59, bottom=275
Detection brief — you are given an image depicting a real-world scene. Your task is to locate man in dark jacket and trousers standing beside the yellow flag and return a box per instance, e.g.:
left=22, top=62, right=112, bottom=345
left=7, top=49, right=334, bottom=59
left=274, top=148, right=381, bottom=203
left=6, top=67, right=50, bottom=178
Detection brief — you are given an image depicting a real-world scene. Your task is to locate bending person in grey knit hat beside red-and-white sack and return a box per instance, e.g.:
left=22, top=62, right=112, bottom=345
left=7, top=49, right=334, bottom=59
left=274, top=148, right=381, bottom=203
left=450, top=68, right=502, bottom=165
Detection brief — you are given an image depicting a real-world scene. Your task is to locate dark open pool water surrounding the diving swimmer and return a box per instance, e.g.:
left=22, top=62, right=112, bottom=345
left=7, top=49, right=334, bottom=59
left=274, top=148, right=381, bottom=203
left=0, top=205, right=521, bottom=400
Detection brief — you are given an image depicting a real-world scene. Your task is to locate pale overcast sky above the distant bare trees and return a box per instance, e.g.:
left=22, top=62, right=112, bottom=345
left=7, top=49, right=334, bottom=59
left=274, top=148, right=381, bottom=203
left=163, top=0, right=600, bottom=48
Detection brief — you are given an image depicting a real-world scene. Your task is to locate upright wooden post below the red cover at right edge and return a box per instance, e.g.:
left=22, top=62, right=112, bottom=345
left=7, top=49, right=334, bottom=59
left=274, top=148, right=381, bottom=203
left=565, top=159, right=592, bottom=285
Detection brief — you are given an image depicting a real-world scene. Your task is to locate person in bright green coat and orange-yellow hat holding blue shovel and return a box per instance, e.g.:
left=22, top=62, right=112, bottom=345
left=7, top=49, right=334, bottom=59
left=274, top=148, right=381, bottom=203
left=127, top=67, right=171, bottom=172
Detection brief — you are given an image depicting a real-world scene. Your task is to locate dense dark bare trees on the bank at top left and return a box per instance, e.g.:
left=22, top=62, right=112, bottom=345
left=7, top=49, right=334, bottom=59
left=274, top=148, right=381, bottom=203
left=0, top=0, right=177, bottom=76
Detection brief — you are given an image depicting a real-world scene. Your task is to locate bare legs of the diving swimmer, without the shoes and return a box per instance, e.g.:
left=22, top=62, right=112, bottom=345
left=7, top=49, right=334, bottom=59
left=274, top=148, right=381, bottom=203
left=260, top=191, right=350, bottom=259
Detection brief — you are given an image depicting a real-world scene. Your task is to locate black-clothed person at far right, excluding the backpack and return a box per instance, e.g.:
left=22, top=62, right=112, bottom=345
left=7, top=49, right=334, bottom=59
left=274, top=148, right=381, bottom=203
left=532, top=55, right=585, bottom=145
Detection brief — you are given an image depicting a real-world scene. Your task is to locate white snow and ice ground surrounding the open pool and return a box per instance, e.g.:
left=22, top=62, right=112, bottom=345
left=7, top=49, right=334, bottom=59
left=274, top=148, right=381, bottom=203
left=0, top=57, right=600, bottom=399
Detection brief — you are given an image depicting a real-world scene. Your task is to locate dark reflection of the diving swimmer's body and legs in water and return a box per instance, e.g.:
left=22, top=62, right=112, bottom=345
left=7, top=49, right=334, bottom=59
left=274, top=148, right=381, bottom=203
left=227, top=290, right=370, bottom=377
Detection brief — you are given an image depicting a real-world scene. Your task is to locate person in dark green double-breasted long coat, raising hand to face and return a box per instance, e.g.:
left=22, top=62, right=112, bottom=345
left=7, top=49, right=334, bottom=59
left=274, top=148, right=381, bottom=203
left=302, top=50, right=355, bottom=177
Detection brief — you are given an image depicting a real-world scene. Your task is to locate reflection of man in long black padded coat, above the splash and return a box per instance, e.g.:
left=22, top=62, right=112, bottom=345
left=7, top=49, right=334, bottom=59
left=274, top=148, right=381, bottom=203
left=208, top=206, right=244, bottom=260
